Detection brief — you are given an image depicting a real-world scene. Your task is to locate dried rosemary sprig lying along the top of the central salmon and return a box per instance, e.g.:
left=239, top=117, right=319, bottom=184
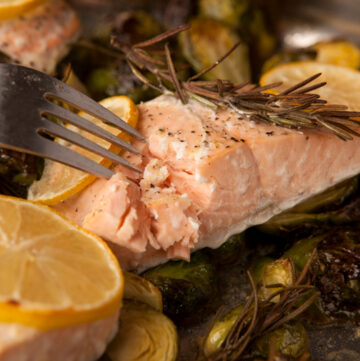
left=112, top=25, right=360, bottom=140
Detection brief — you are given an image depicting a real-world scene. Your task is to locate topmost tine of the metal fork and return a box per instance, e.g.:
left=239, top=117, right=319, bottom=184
left=45, top=78, right=144, bottom=140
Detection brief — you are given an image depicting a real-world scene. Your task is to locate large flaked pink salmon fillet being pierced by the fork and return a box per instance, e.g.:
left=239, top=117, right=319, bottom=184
left=56, top=95, right=360, bottom=271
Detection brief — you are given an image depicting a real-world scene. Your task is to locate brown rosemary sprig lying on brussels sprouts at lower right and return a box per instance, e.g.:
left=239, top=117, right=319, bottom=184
left=200, top=250, right=319, bottom=361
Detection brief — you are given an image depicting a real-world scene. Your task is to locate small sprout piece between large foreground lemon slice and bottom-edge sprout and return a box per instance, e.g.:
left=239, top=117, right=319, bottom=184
left=124, top=272, right=163, bottom=312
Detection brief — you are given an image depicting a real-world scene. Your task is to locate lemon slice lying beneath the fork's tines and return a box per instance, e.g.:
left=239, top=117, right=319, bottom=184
left=28, top=96, right=138, bottom=205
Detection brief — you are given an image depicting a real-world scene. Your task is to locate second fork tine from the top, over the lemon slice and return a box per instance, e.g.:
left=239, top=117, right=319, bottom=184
left=41, top=102, right=140, bottom=154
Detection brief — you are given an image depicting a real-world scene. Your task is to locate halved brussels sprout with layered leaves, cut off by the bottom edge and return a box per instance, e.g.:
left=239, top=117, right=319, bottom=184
left=107, top=303, right=178, bottom=361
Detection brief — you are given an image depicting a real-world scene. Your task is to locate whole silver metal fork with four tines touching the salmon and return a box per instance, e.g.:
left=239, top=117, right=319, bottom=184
left=0, top=64, right=144, bottom=178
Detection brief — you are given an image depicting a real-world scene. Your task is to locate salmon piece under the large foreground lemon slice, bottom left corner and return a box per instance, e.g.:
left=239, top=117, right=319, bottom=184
left=0, top=312, right=118, bottom=361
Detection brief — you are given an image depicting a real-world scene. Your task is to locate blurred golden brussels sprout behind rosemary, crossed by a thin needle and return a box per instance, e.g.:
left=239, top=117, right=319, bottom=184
left=179, top=18, right=250, bottom=83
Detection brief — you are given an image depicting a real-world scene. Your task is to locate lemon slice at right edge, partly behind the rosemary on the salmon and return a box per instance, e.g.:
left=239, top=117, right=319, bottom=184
left=260, top=61, right=360, bottom=110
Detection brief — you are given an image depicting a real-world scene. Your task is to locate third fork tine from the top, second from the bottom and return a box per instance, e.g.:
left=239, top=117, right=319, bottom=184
left=37, top=118, right=141, bottom=173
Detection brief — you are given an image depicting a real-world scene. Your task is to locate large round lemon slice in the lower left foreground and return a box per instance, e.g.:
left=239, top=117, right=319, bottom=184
left=0, top=196, right=124, bottom=330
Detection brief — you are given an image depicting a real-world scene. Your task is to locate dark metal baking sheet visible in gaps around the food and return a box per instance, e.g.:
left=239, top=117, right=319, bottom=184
left=70, top=0, right=360, bottom=361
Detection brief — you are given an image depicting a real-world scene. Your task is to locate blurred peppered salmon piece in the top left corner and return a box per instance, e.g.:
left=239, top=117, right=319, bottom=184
left=0, top=0, right=80, bottom=74
